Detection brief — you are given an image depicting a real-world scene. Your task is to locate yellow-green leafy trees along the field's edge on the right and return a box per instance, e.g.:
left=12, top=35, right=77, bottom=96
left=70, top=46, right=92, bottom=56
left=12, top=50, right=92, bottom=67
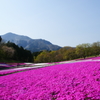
left=34, top=42, right=100, bottom=63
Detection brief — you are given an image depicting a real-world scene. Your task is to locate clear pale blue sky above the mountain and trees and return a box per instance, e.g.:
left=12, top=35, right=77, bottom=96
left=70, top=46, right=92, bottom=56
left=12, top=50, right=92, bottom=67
left=0, top=0, right=100, bottom=47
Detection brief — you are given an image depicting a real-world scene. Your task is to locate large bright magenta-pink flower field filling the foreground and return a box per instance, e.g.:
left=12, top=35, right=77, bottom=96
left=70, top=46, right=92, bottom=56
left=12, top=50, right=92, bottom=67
left=0, top=61, right=100, bottom=100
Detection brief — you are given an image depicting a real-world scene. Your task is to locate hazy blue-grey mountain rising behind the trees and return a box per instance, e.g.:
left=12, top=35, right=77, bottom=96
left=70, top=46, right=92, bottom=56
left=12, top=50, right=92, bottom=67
left=1, top=32, right=61, bottom=52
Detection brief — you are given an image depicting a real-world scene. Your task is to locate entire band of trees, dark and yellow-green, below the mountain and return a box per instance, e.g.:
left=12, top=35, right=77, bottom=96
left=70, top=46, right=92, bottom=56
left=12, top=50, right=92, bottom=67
left=0, top=36, right=100, bottom=63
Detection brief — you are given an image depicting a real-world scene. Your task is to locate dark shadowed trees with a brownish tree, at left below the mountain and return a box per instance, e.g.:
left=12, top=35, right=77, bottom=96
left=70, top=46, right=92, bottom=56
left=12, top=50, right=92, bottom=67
left=0, top=36, right=33, bottom=62
